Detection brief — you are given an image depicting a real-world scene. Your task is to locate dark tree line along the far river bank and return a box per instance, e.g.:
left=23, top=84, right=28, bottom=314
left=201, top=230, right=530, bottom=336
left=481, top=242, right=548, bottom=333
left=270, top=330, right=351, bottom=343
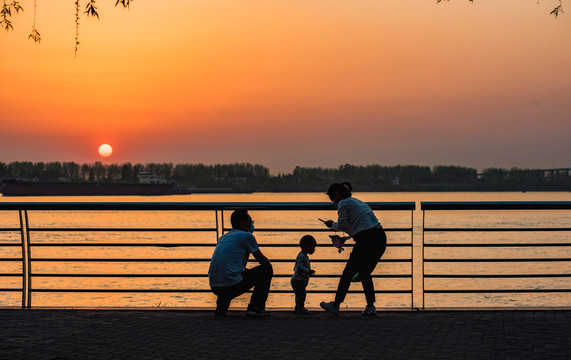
left=0, top=161, right=571, bottom=191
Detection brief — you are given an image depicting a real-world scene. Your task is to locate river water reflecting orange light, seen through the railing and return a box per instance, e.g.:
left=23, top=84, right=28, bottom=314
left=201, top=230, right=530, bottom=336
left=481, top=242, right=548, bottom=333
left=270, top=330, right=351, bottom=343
left=0, top=192, right=571, bottom=308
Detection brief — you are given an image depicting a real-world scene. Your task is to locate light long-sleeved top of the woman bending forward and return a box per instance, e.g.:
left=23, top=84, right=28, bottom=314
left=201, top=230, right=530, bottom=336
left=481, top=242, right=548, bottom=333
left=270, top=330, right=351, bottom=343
left=333, top=197, right=381, bottom=237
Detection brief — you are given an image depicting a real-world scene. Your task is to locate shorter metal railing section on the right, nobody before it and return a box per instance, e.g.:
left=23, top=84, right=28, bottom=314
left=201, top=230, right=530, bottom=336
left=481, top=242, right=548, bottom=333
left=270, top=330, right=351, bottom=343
left=421, top=201, right=571, bottom=308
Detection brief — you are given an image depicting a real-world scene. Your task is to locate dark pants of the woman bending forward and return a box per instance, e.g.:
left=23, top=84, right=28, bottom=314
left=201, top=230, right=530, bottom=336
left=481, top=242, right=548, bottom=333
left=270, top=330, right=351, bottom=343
left=335, top=228, right=387, bottom=305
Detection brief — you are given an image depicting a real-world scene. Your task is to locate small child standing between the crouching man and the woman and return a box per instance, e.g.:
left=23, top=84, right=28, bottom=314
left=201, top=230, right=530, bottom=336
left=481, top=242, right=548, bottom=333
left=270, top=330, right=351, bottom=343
left=291, top=235, right=317, bottom=315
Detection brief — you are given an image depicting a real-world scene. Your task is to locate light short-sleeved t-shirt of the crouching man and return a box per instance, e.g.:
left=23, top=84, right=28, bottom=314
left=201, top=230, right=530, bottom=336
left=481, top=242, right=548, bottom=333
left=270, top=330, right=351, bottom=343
left=208, top=229, right=259, bottom=287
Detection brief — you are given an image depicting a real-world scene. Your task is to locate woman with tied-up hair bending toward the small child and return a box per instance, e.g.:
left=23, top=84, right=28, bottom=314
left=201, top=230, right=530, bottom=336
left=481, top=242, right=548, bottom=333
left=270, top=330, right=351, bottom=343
left=321, top=182, right=387, bottom=315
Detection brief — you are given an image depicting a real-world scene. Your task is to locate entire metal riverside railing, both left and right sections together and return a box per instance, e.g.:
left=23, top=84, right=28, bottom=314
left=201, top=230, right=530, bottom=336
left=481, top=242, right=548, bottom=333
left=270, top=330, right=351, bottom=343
left=0, top=201, right=571, bottom=308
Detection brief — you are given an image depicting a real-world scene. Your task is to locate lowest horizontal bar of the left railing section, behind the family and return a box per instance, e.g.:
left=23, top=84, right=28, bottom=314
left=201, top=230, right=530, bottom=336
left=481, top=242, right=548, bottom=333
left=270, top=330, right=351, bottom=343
left=30, top=289, right=412, bottom=294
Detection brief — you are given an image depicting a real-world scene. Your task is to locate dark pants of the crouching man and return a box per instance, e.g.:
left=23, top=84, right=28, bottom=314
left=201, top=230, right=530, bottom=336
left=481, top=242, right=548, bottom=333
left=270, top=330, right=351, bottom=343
left=212, top=263, right=274, bottom=316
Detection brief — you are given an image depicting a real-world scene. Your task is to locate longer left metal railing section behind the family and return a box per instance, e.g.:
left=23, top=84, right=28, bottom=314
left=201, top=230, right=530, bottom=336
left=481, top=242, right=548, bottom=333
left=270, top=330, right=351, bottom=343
left=0, top=202, right=415, bottom=308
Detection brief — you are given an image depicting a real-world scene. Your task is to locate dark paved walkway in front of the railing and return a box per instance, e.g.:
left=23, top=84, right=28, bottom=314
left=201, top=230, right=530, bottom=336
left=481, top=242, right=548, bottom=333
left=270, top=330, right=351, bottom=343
left=0, top=310, right=571, bottom=360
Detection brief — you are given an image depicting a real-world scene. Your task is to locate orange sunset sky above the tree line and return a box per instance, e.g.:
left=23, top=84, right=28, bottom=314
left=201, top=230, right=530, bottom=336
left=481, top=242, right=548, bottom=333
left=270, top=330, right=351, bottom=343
left=0, top=0, right=571, bottom=174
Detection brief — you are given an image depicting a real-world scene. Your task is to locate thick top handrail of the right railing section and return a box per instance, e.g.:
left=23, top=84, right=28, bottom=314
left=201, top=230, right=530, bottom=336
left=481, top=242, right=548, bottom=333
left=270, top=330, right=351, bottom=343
left=420, top=201, right=571, bottom=210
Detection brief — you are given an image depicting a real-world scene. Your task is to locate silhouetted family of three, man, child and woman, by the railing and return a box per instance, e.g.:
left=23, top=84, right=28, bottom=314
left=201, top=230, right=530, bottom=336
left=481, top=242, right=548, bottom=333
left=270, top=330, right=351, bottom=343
left=208, top=182, right=387, bottom=317
